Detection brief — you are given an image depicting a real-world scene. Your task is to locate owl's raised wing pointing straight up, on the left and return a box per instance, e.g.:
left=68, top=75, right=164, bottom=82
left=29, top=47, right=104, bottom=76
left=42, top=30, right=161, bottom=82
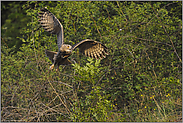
left=38, top=7, right=64, bottom=49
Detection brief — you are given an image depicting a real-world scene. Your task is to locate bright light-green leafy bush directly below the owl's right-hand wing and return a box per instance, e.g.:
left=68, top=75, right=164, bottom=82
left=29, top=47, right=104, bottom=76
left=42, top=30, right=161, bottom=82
left=72, top=58, right=113, bottom=122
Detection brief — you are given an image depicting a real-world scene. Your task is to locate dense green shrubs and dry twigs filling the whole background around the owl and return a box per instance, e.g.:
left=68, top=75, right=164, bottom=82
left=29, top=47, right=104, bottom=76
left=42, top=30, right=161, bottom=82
left=1, top=1, right=182, bottom=122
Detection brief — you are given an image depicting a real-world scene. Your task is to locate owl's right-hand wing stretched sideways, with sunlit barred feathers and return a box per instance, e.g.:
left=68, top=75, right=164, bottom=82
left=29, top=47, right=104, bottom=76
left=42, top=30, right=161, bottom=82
left=72, top=39, right=108, bottom=59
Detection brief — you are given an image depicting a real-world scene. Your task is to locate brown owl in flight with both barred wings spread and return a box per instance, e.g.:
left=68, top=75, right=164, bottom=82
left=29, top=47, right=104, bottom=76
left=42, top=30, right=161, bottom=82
left=38, top=7, right=108, bottom=71
